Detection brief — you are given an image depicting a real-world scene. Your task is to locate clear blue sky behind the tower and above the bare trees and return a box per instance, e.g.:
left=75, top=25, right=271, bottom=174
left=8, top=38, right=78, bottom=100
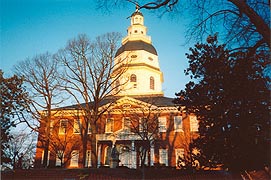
left=0, top=0, right=191, bottom=97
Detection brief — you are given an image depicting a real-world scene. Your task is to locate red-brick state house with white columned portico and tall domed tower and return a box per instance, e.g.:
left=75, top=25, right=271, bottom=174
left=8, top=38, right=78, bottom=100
left=35, top=10, right=198, bottom=168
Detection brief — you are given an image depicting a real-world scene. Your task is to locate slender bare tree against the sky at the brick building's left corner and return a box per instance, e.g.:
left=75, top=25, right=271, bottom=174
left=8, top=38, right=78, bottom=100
left=14, top=53, right=63, bottom=167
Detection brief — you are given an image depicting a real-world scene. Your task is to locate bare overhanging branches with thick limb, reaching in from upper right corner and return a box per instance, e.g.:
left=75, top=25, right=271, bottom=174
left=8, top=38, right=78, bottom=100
left=97, top=0, right=270, bottom=51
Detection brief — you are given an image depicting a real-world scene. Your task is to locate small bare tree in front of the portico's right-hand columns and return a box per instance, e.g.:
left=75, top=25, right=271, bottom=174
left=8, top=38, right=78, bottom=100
left=118, top=97, right=161, bottom=179
